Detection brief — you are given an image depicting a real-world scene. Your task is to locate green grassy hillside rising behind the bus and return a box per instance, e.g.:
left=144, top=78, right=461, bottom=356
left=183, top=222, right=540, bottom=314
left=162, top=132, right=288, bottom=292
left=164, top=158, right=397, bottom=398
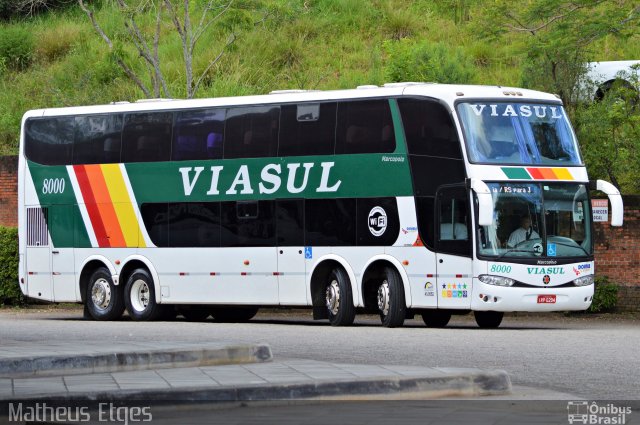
left=0, top=0, right=640, bottom=154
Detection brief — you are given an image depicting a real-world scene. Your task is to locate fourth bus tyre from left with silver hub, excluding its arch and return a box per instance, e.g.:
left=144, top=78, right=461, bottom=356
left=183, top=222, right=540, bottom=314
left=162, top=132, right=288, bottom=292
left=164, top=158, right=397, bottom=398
left=378, top=267, right=407, bottom=328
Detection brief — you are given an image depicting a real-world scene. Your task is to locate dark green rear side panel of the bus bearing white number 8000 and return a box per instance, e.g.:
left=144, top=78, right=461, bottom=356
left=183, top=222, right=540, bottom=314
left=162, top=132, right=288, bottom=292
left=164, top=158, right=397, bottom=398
left=27, top=161, right=91, bottom=248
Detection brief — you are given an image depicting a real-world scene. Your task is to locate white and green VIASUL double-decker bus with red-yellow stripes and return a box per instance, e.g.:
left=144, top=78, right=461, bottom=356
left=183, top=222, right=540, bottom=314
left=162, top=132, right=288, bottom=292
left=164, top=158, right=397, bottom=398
left=19, top=83, right=622, bottom=327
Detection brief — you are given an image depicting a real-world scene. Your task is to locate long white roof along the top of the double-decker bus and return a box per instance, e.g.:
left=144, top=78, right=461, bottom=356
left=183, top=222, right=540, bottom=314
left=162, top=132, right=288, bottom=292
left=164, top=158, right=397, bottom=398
left=24, top=83, right=559, bottom=119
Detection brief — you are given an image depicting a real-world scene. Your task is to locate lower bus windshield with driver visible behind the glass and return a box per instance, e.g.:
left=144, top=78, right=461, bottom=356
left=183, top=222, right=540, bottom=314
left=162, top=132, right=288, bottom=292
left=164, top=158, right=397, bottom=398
left=478, top=183, right=592, bottom=259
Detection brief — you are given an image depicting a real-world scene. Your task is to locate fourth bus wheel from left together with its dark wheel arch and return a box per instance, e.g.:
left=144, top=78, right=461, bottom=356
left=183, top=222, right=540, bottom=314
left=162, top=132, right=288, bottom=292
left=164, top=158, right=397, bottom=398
left=362, top=259, right=408, bottom=328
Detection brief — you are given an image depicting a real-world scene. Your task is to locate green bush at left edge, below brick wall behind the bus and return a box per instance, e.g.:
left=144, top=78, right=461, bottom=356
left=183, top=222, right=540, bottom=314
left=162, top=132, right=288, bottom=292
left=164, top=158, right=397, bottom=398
left=0, top=226, right=25, bottom=305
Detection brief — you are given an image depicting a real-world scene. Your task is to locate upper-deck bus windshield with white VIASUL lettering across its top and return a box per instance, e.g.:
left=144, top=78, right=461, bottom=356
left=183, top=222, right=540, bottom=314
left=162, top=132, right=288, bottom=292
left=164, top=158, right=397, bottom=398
left=457, top=101, right=581, bottom=165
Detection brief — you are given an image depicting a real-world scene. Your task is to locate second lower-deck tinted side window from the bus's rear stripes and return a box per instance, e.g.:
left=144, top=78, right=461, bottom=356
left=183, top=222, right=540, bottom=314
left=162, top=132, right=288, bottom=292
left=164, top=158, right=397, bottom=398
left=169, top=202, right=220, bottom=247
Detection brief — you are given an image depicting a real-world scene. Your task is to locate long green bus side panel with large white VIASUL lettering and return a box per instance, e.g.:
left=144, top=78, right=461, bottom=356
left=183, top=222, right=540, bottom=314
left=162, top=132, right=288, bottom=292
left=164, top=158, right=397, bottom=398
left=126, top=153, right=412, bottom=204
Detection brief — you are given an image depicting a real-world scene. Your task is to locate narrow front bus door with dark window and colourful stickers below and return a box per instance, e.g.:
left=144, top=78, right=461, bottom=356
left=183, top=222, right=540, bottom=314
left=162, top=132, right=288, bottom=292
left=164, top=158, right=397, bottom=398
left=435, top=185, right=473, bottom=309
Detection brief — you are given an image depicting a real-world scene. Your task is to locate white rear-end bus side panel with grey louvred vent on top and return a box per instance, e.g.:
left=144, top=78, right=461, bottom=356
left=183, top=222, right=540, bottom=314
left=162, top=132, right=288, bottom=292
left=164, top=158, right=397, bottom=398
left=25, top=207, right=53, bottom=300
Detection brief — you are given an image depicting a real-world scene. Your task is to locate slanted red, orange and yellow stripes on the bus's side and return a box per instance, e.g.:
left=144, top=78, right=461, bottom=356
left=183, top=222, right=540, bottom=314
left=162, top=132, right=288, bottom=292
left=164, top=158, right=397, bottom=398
left=73, top=164, right=145, bottom=248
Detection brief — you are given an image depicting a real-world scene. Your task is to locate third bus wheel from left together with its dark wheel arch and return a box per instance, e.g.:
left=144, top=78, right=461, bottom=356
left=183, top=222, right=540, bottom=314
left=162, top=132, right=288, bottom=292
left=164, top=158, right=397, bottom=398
left=309, top=255, right=356, bottom=326
